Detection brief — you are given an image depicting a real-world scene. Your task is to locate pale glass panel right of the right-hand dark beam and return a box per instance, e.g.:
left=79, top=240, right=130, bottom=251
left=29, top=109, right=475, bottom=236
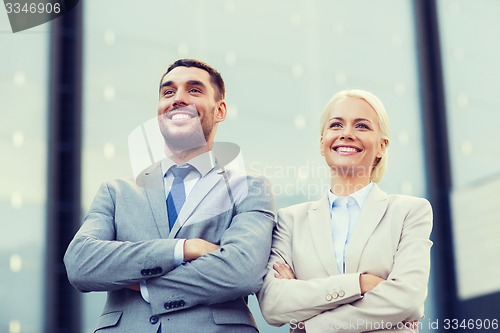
left=439, top=0, right=500, bottom=301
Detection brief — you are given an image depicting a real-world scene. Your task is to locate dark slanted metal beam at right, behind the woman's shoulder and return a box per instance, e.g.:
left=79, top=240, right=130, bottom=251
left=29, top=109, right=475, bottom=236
left=413, top=0, right=458, bottom=318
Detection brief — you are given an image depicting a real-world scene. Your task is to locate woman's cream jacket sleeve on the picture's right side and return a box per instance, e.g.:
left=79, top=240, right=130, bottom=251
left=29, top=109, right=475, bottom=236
left=305, top=199, right=432, bottom=333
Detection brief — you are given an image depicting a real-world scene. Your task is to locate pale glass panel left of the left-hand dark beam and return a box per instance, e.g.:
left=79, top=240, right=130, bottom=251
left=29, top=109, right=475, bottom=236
left=0, top=11, right=49, bottom=333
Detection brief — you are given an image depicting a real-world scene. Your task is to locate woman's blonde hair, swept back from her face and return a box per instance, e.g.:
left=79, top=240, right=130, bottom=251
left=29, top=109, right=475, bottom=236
left=320, top=89, right=389, bottom=183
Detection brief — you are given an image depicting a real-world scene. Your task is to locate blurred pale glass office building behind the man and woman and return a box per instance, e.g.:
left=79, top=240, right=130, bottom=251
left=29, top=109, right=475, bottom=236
left=0, top=0, right=500, bottom=333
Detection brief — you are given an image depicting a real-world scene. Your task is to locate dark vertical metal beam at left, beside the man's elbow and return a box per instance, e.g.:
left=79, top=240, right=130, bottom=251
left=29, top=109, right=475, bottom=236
left=44, top=4, right=82, bottom=333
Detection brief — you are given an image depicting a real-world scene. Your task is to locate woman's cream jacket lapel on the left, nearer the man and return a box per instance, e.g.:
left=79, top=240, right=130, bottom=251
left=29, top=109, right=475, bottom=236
left=308, top=192, right=339, bottom=275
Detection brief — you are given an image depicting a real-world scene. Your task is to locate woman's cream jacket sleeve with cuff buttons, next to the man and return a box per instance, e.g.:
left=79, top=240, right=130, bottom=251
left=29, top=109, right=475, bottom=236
left=258, top=211, right=361, bottom=326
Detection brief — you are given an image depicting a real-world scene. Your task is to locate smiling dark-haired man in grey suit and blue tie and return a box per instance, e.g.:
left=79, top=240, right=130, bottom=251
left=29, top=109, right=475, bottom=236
left=64, top=59, right=274, bottom=333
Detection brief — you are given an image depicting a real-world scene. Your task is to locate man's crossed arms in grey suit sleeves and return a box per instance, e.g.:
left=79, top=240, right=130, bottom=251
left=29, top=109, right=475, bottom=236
left=65, top=175, right=274, bottom=314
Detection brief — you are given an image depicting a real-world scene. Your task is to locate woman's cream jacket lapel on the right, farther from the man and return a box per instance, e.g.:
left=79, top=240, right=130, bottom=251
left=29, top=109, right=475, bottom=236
left=346, top=184, right=387, bottom=273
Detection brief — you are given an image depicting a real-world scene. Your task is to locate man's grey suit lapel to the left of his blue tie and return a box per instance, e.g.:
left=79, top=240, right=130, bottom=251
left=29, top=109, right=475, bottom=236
left=137, top=163, right=172, bottom=238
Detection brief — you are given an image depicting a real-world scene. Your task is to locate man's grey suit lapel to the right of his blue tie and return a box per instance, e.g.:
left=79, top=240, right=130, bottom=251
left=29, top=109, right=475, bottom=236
left=169, top=167, right=222, bottom=238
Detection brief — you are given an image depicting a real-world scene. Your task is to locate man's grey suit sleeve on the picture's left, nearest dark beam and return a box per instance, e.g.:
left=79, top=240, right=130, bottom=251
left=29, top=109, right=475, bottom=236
left=64, top=180, right=178, bottom=292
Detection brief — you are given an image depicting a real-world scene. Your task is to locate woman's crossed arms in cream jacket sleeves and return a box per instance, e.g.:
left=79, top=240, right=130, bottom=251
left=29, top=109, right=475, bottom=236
left=259, top=200, right=432, bottom=332
